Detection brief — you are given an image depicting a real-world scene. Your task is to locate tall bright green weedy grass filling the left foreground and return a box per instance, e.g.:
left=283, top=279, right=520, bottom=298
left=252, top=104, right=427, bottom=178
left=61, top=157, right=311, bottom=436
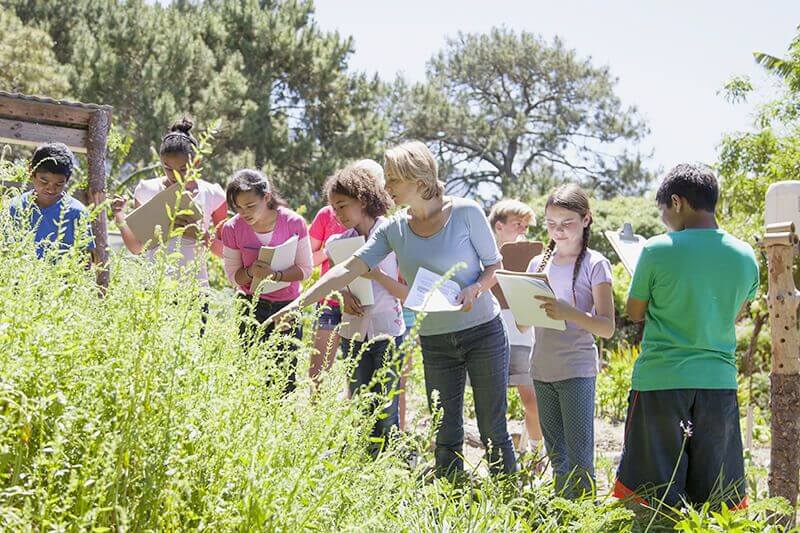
left=0, top=179, right=792, bottom=531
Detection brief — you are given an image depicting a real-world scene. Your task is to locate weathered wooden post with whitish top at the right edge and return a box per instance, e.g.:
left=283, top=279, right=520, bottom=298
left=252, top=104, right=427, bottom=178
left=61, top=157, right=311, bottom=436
left=763, top=222, right=800, bottom=526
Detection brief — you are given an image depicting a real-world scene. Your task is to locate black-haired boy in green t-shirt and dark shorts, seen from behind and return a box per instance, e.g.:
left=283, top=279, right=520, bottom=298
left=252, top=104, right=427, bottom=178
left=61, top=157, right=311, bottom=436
left=614, top=165, right=759, bottom=507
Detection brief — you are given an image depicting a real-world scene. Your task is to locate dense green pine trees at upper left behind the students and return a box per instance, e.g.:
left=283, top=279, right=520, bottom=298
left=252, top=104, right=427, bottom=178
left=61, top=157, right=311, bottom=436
left=10, top=0, right=386, bottom=211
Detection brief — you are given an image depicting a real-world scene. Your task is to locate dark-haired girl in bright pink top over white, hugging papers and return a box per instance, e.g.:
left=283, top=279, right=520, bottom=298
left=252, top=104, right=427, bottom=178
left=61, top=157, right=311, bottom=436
left=222, top=169, right=313, bottom=393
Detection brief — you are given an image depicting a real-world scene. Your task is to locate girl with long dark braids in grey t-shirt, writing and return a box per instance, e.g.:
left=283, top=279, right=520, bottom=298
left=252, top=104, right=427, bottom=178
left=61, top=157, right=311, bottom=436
left=528, top=184, right=614, bottom=498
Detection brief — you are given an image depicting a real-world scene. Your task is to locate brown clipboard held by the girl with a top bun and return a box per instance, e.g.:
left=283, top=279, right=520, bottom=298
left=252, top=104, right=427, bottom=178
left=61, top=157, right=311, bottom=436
left=125, top=183, right=203, bottom=250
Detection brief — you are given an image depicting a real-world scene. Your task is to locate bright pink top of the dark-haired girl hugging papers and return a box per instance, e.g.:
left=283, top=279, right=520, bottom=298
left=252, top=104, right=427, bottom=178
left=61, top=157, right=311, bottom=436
left=222, top=207, right=311, bottom=302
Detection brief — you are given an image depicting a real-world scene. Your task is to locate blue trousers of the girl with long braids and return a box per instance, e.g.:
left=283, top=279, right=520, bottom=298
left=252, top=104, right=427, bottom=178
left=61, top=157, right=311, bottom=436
left=533, top=378, right=595, bottom=498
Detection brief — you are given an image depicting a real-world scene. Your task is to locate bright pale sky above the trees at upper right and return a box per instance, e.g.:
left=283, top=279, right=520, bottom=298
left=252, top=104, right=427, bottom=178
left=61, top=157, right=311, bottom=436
left=315, top=0, right=800, bottom=174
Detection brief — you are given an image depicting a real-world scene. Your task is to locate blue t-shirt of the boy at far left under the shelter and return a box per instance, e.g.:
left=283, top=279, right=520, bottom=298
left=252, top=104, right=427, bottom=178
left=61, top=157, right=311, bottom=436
left=9, top=191, right=95, bottom=259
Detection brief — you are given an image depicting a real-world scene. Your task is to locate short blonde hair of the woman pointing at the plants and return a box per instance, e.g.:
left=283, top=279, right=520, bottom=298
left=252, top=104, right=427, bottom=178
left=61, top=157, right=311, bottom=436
left=383, top=141, right=444, bottom=200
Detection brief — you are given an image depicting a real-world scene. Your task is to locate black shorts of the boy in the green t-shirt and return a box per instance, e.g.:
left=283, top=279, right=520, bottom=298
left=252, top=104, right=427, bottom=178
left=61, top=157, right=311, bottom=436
left=614, top=389, right=747, bottom=508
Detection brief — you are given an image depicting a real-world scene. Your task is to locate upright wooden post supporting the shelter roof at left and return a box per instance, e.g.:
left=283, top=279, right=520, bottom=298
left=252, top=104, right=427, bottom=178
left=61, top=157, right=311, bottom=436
left=86, top=110, right=110, bottom=289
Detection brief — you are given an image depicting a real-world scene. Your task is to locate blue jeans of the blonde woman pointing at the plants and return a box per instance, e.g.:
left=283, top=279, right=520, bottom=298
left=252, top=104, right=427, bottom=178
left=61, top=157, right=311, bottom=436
left=420, top=316, right=517, bottom=476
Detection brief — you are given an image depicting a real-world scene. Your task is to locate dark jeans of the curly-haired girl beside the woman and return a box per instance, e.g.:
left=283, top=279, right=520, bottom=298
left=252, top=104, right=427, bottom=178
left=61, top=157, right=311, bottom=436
left=341, top=335, right=403, bottom=445
